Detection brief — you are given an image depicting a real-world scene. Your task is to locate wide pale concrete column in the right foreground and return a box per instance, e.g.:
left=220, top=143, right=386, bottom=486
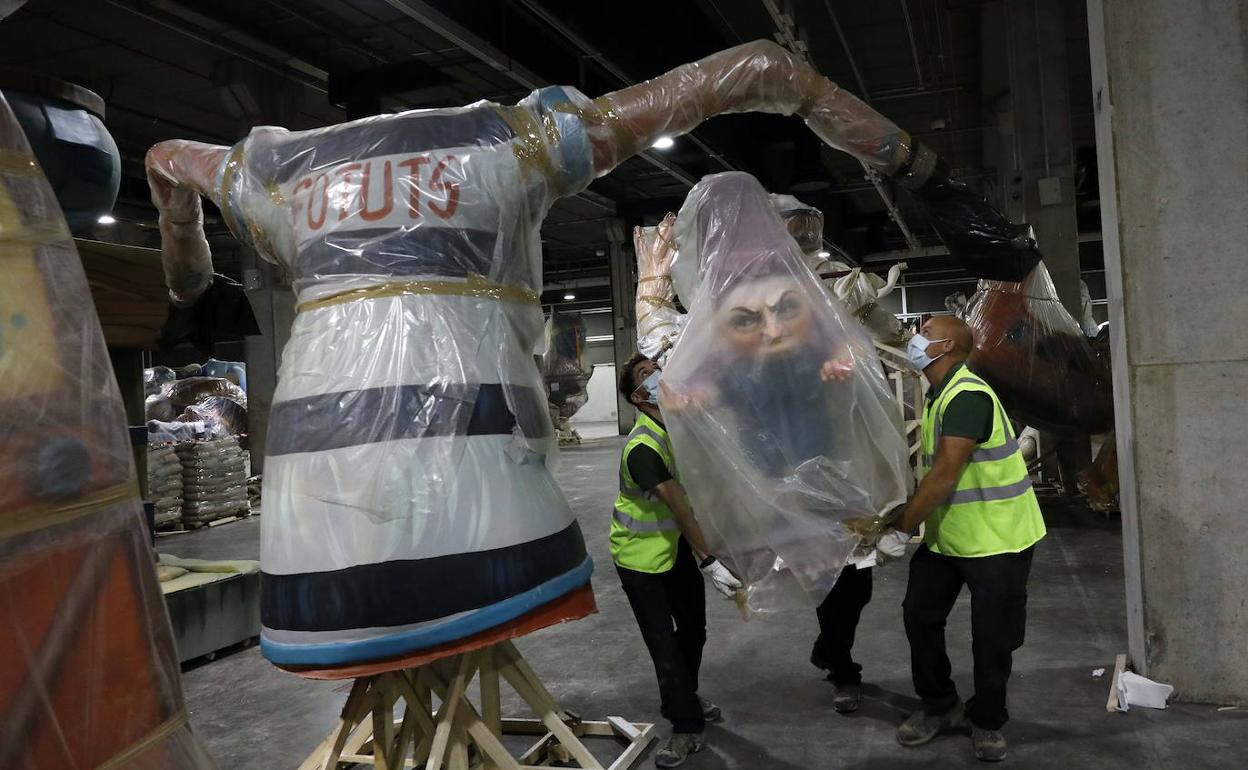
left=1088, top=0, right=1248, bottom=703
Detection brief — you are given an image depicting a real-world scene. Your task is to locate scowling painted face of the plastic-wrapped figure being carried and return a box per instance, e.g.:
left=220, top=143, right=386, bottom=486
left=716, top=276, right=814, bottom=357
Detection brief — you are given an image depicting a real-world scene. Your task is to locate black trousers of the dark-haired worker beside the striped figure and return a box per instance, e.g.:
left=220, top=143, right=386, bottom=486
left=615, top=538, right=706, bottom=733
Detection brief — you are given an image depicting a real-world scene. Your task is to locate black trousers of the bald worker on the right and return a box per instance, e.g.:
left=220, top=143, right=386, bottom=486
left=902, top=545, right=1035, bottom=730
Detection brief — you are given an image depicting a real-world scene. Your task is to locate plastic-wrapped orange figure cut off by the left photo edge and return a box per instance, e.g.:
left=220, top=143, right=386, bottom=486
left=0, top=92, right=213, bottom=770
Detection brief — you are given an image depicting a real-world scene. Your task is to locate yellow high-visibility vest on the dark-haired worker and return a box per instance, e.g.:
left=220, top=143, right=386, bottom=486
left=610, top=413, right=680, bottom=573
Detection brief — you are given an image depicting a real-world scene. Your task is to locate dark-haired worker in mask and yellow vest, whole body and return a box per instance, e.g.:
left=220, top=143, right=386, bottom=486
left=610, top=353, right=741, bottom=768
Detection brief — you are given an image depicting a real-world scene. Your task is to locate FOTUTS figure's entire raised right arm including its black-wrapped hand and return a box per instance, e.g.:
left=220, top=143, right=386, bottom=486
left=588, top=40, right=1041, bottom=281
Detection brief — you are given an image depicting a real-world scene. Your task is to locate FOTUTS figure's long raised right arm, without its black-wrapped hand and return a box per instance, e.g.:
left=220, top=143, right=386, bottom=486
left=588, top=40, right=910, bottom=175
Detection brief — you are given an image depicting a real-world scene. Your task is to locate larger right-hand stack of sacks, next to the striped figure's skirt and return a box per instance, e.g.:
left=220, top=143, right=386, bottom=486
left=176, top=437, right=251, bottom=524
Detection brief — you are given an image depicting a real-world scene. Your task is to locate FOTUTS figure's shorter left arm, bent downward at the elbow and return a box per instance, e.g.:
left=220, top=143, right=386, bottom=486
left=146, top=140, right=230, bottom=307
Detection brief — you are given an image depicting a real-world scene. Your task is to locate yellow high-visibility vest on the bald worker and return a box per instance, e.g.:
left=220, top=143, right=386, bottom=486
left=921, top=364, right=1045, bottom=557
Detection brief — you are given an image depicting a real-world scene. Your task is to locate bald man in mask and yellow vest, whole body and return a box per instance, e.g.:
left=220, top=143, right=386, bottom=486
left=897, top=316, right=1045, bottom=761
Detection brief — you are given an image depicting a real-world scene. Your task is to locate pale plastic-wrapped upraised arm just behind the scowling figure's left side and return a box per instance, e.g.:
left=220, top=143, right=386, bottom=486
left=633, top=213, right=685, bottom=366
